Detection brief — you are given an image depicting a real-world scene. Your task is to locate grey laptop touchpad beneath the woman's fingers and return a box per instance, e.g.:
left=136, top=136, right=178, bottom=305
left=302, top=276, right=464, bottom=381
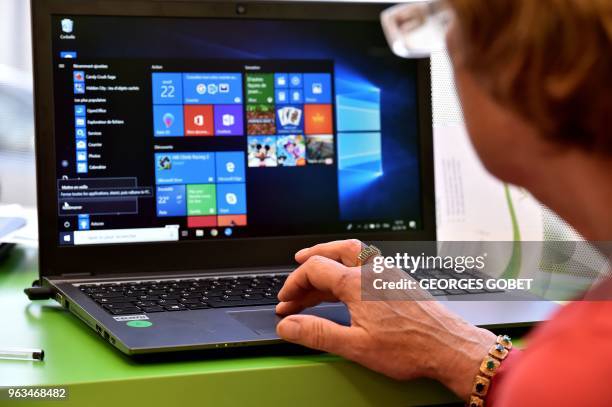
left=228, top=305, right=351, bottom=335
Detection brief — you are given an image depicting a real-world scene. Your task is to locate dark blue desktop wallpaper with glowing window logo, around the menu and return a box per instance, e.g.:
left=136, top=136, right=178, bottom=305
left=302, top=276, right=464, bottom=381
left=64, top=17, right=422, bottom=226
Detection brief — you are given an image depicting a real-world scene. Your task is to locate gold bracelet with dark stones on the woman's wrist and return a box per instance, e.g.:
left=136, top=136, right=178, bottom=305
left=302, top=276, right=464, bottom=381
left=468, top=335, right=512, bottom=407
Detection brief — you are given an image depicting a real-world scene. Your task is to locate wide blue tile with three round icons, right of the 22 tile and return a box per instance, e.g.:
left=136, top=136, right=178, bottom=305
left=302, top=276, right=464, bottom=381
left=183, top=73, right=243, bottom=105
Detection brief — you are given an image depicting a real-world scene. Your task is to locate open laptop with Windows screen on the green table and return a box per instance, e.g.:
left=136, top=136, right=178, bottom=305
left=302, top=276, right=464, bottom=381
left=32, top=0, right=549, bottom=355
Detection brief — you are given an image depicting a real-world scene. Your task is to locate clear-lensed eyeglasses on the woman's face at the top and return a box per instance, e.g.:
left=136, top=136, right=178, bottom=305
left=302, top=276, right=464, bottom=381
left=381, top=0, right=453, bottom=58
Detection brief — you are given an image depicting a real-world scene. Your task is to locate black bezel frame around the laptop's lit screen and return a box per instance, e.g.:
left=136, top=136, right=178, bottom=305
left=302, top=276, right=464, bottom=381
left=32, top=0, right=436, bottom=278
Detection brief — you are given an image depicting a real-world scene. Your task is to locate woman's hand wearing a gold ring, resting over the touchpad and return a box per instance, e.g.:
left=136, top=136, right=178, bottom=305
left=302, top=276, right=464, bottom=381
left=276, top=240, right=495, bottom=400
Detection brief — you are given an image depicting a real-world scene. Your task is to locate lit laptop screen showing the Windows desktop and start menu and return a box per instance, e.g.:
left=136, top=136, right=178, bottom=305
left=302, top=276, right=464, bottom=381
left=52, top=15, right=423, bottom=245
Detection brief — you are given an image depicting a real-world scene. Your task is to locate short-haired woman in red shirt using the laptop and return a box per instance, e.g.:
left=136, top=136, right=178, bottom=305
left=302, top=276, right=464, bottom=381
left=277, top=0, right=612, bottom=406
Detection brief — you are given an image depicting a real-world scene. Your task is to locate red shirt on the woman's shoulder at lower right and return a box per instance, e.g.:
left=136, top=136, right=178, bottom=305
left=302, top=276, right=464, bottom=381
left=486, top=290, right=612, bottom=407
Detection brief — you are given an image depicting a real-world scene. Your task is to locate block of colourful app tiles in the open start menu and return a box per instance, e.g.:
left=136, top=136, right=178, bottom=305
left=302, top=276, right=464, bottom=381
left=151, top=61, right=336, bottom=234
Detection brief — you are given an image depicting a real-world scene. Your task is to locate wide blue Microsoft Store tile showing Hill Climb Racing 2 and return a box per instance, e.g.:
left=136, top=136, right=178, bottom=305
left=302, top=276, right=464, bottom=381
left=155, top=153, right=215, bottom=185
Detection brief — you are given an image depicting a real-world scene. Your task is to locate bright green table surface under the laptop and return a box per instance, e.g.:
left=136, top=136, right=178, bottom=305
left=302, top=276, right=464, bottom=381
left=0, top=248, right=457, bottom=407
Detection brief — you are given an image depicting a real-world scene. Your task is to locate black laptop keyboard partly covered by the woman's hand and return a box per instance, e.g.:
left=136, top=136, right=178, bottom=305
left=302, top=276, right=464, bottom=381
left=79, top=270, right=501, bottom=315
